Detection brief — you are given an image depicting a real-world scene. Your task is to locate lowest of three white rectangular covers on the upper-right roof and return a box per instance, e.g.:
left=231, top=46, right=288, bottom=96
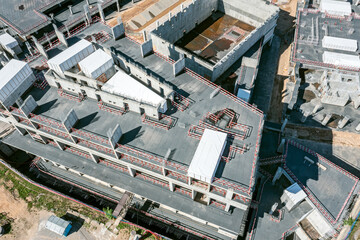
left=323, top=51, right=360, bottom=68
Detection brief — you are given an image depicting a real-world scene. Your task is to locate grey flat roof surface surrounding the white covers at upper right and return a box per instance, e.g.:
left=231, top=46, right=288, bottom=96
left=292, top=9, right=360, bottom=70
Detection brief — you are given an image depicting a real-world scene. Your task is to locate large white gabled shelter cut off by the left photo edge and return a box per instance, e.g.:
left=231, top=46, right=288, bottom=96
left=0, top=59, right=33, bottom=102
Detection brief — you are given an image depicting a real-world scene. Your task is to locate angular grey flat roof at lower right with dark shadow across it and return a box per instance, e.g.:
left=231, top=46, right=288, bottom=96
left=285, top=140, right=359, bottom=225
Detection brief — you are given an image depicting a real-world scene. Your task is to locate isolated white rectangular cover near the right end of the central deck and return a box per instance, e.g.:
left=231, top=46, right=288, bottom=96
left=188, top=129, right=227, bottom=183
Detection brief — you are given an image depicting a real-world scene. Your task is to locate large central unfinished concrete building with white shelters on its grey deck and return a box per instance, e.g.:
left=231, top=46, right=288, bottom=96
left=0, top=26, right=264, bottom=239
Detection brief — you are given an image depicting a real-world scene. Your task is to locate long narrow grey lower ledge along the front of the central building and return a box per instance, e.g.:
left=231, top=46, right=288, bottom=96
left=2, top=131, right=245, bottom=232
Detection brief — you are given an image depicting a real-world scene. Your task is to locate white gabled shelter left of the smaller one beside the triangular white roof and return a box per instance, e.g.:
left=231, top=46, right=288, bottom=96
left=48, top=39, right=94, bottom=75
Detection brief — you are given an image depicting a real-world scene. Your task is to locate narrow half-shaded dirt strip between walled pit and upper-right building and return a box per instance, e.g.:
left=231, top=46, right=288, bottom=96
left=267, top=0, right=298, bottom=123
